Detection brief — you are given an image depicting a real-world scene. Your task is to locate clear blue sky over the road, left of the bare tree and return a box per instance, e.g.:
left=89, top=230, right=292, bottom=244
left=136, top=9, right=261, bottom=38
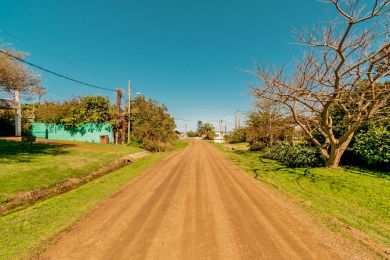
left=0, top=0, right=328, bottom=130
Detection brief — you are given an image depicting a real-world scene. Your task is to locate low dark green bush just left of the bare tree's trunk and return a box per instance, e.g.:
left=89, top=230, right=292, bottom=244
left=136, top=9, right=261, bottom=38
left=263, top=142, right=324, bottom=168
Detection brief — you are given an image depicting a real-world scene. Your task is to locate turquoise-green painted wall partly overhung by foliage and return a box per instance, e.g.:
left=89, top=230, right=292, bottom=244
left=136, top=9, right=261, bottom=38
left=32, top=123, right=114, bottom=143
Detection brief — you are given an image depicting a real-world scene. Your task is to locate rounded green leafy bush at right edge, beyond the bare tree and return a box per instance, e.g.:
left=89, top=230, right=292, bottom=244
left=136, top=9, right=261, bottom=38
left=350, top=120, right=390, bottom=169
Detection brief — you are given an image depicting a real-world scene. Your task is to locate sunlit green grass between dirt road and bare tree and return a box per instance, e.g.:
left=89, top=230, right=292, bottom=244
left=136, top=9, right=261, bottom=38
left=216, top=145, right=390, bottom=251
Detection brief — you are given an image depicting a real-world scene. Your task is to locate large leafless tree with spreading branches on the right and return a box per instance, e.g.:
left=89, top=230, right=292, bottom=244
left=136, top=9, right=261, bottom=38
left=252, top=0, right=390, bottom=168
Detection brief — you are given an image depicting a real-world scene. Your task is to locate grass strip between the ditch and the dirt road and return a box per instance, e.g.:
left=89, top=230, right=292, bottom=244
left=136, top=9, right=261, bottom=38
left=0, top=153, right=169, bottom=259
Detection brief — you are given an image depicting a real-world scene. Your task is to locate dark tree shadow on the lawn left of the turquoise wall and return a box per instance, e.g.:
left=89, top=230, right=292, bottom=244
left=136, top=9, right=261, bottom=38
left=0, top=140, right=74, bottom=164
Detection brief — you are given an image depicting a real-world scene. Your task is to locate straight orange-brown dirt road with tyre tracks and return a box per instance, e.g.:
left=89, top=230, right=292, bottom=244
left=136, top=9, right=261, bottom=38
left=42, top=141, right=337, bottom=260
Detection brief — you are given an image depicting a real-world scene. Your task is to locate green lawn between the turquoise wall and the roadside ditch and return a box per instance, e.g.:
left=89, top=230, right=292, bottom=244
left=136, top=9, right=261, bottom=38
left=0, top=140, right=142, bottom=202
